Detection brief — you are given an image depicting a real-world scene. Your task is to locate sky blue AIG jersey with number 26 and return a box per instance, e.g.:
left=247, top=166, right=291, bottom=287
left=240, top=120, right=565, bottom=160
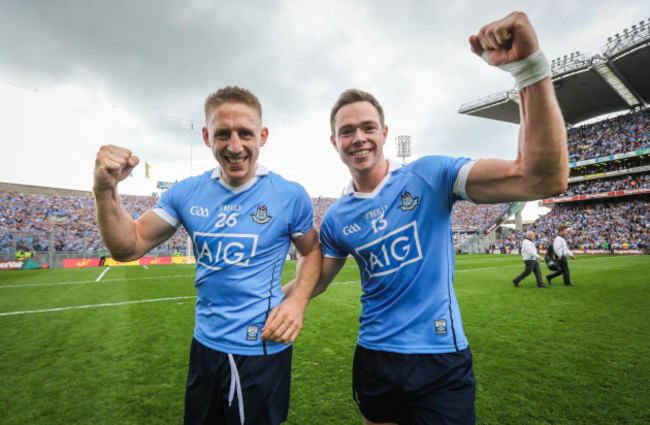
left=152, top=164, right=314, bottom=355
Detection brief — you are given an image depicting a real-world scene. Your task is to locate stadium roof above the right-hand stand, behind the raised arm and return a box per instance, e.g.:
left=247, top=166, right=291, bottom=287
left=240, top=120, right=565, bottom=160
left=458, top=19, right=650, bottom=126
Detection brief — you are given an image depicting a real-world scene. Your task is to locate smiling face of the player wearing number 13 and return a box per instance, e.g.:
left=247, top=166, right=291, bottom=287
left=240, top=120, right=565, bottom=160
left=330, top=101, right=388, bottom=190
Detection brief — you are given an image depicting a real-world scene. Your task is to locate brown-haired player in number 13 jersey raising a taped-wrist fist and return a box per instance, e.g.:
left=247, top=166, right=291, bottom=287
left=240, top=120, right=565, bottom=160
left=284, top=12, right=569, bottom=425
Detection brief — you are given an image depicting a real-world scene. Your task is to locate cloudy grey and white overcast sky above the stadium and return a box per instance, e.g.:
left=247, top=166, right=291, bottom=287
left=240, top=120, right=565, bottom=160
left=0, top=0, right=650, bottom=205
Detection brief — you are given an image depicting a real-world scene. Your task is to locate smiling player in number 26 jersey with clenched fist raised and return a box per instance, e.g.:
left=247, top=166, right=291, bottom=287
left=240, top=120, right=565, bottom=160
left=94, top=87, right=322, bottom=425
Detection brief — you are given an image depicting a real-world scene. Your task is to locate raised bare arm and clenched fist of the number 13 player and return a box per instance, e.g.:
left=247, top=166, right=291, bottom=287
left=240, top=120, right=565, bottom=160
left=466, top=12, right=569, bottom=203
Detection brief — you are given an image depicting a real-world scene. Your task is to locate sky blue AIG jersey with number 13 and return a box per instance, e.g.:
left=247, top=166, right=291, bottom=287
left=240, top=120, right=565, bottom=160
left=320, top=156, right=469, bottom=354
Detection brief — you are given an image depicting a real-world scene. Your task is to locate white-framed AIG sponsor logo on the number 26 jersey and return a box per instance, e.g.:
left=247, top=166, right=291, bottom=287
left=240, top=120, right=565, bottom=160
left=194, top=232, right=258, bottom=270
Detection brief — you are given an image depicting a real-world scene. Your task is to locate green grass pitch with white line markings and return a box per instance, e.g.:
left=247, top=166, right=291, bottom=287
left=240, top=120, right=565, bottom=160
left=0, top=255, right=650, bottom=425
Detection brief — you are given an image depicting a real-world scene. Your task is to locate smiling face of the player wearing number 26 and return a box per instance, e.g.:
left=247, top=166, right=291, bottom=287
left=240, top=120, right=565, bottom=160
left=203, top=102, right=269, bottom=187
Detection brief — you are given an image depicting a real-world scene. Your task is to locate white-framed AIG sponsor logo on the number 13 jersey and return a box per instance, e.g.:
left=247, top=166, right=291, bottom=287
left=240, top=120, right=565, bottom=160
left=355, top=221, right=422, bottom=277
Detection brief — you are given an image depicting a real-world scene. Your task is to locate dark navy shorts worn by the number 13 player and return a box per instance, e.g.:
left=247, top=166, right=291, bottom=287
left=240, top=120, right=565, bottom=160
left=352, top=345, right=476, bottom=425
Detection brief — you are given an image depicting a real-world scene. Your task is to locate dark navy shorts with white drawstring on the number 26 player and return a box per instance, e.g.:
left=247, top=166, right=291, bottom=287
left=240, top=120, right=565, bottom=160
left=184, top=339, right=292, bottom=425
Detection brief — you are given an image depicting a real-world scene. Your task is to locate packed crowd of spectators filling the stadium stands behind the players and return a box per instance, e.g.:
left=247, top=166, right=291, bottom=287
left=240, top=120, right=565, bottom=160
left=7, top=186, right=650, bottom=253
